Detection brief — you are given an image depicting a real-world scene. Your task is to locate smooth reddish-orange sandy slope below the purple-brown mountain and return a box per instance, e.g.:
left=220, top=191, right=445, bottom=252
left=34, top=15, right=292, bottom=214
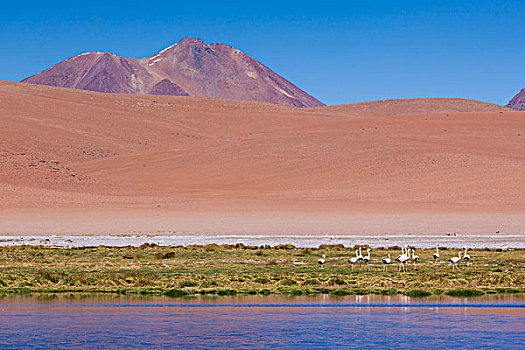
left=0, top=82, right=525, bottom=238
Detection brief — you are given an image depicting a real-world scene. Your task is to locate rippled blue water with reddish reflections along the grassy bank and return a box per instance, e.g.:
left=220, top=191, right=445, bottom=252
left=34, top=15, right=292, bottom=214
left=0, top=297, right=525, bottom=349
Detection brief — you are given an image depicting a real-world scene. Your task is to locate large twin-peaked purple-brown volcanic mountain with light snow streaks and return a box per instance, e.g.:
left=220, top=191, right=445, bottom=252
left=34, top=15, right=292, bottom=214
left=22, top=38, right=324, bottom=107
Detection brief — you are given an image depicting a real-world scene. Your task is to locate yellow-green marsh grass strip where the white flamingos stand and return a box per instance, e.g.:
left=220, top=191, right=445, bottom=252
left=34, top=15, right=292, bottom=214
left=0, top=244, right=525, bottom=297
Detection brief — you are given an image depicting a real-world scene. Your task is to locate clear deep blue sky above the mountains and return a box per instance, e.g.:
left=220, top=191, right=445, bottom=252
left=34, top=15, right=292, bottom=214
left=0, top=0, right=525, bottom=104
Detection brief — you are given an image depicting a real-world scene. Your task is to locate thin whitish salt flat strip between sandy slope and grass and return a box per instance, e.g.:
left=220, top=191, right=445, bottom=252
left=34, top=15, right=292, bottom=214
left=0, top=233, right=525, bottom=249
